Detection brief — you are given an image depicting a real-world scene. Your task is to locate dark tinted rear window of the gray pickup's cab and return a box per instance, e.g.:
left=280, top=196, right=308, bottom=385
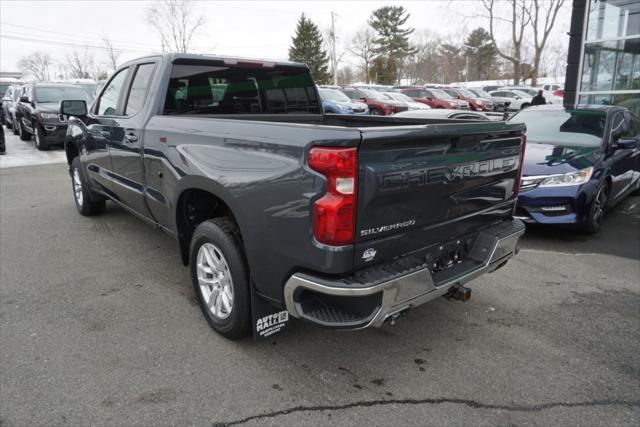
left=164, top=61, right=321, bottom=114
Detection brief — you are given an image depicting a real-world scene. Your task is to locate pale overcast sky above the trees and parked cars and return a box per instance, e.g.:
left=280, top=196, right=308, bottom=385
left=0, top=0, right=570, bottom=76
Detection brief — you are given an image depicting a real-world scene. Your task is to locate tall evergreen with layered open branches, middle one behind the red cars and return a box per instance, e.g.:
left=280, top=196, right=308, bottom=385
left=369, top=6, right=415, bottom=83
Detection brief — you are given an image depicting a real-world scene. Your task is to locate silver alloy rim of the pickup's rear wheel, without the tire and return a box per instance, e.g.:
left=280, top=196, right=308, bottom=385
left=197, top=243, right=233, bottom=320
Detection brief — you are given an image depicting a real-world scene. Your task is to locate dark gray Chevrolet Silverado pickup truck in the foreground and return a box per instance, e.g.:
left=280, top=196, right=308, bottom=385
left=61, top=54, right=525, bottom=339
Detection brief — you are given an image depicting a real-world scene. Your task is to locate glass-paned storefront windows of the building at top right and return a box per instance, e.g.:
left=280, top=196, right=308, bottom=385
left=578, top=0, right=640, bottom=114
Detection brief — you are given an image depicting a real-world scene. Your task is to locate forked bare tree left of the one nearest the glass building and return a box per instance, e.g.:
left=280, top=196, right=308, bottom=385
left=482, top=0, right=531, bottom=85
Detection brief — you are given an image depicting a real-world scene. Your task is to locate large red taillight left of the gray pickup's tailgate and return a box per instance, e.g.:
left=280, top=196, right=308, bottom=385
left=309, top=147, right=358, bottom=246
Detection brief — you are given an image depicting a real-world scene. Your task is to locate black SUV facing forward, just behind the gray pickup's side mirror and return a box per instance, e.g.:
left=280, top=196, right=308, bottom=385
left=15, top=83, right=90, bottom=150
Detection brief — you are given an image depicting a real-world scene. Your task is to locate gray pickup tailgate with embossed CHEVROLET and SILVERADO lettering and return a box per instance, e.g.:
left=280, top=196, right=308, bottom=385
left=354, top=122, right=524, bottom=268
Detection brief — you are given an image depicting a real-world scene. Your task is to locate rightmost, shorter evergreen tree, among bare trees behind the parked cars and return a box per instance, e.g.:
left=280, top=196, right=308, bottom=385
left=464, top=28, right=498, bottom=80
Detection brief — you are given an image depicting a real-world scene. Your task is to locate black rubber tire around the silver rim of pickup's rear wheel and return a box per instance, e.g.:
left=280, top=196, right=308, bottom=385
left=189, top=218, right=251, bottom=340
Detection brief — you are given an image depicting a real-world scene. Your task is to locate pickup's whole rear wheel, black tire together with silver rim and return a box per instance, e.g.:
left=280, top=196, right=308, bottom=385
left=190, top=218, right=251, bottom=340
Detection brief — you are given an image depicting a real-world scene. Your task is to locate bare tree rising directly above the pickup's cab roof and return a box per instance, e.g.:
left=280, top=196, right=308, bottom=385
left=147, top=0, right=205, bottom=53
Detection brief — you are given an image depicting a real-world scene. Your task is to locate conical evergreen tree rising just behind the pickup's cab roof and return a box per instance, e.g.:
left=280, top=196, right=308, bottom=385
left=289, top=13, right=331, bottom=84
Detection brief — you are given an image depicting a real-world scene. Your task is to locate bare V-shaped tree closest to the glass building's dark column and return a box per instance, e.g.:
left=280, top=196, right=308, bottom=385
left=525, top=0, right=564, bottom=86
